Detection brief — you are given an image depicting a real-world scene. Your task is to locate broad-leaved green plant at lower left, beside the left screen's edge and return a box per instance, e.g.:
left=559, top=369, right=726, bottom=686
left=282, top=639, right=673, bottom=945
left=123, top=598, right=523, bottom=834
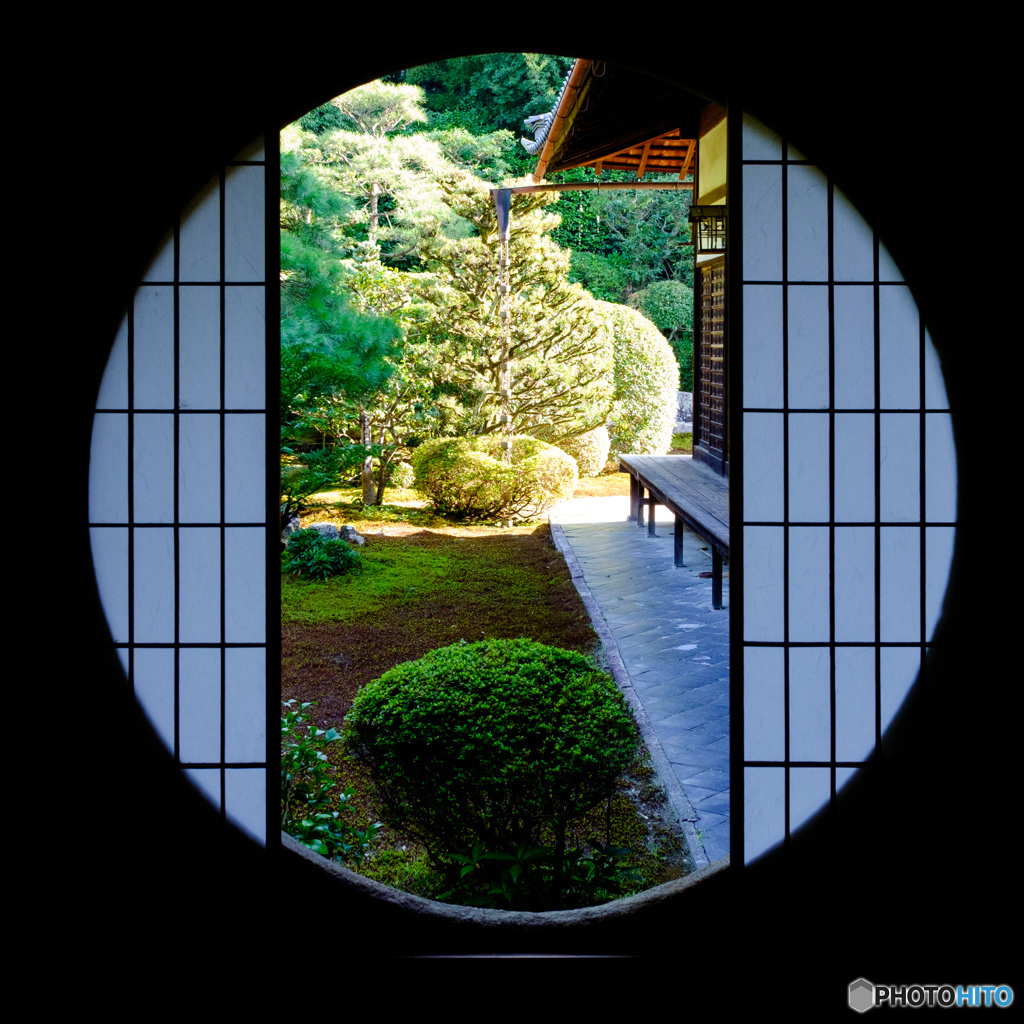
left=281, top=700, right=382, bottom=863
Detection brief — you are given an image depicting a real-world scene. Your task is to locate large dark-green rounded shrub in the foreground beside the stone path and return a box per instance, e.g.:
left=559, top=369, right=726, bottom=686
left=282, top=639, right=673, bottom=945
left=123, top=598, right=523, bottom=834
left=345, top=640, right=637, bottom=857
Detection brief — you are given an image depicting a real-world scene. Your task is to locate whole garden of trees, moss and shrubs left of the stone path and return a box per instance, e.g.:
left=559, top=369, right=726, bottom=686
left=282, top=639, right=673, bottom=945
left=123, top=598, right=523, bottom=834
left=281, top=53, right=692, bottom=910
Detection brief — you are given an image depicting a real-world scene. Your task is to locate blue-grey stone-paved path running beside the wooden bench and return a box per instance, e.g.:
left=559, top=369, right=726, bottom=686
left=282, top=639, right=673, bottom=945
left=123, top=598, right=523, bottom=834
left=550, top=497, right=729, bottom=867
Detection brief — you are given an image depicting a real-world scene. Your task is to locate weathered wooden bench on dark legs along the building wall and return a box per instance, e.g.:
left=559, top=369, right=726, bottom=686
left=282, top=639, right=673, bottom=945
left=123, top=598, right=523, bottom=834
left=618, top=455, right=729, bottom=608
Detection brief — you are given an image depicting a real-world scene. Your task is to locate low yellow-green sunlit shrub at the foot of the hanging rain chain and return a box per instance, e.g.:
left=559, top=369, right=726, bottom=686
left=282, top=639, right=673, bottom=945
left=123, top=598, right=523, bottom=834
left=413, top=434, right=579, bottom=519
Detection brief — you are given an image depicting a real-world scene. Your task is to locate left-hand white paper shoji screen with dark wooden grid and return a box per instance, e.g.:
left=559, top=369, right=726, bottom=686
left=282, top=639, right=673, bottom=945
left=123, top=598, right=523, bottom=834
left=89, top=140, right=278, bottom=843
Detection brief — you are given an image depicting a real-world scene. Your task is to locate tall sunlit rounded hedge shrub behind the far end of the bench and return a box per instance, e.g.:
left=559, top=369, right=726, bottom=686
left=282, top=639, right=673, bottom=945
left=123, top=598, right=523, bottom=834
left=594, top=302, right=679, bottom=457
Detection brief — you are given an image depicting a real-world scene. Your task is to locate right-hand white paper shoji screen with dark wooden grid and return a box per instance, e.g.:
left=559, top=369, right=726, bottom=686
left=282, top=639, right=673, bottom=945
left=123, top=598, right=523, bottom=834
left=730, top=117, right=956, bottom=862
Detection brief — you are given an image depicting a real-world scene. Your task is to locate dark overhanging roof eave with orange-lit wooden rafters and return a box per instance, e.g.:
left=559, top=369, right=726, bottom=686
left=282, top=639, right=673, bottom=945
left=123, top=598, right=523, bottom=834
left=524, top=58, right=707, bottom=181
